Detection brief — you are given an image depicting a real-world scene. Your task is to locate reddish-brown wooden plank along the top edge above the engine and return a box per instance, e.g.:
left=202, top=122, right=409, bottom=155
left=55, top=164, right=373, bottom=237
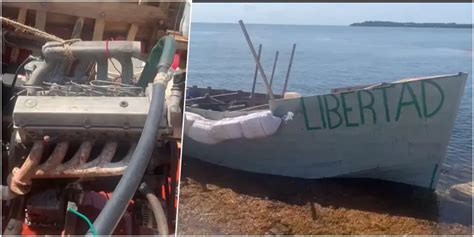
left=2, top=2, right=168, bottom=24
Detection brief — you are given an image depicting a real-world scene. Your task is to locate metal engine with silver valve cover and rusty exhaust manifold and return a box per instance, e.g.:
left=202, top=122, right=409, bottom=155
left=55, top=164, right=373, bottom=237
left=9, top=41, right=182, bottom=195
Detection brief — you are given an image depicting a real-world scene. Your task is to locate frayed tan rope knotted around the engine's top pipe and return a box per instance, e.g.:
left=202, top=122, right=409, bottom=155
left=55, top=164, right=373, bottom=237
left=1, top=16, right=81, bottom=61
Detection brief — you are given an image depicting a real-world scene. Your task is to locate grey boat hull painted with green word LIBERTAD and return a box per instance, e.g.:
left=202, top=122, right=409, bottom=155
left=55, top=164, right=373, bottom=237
left=183, top=73, right=467, bottom=189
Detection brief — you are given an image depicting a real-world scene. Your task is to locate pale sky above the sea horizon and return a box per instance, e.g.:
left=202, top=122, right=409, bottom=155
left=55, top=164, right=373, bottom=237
left=192, top=3, right=472, bottom=25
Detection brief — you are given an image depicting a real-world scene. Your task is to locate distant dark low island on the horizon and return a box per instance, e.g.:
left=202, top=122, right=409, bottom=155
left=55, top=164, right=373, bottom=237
left=350, top=21, right=472, bottom=28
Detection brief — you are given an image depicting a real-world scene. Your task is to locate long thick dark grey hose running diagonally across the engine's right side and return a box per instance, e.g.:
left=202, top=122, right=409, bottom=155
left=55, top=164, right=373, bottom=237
left=87, top=83, right=166, bottom=236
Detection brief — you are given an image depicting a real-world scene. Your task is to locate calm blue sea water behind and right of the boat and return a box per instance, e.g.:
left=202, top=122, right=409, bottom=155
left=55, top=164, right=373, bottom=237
left=187, top=23, right=472, bottom=191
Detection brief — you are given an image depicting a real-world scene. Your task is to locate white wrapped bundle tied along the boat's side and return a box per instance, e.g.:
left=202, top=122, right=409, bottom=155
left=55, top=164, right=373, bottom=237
left=184, top=110, right=282, bottom=144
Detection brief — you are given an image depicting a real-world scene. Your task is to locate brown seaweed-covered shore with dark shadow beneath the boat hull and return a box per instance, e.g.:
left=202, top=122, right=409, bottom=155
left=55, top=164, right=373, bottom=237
left=178, top=157, right=472, bottom=234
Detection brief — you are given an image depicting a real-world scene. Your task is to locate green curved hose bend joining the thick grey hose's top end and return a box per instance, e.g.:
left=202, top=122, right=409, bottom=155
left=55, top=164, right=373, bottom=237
left=137, top=35, right=176, bottom=87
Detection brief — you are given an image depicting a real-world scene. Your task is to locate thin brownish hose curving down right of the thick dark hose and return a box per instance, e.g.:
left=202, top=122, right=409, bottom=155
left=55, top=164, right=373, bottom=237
left=138, top=182, right=169, bottom=235
